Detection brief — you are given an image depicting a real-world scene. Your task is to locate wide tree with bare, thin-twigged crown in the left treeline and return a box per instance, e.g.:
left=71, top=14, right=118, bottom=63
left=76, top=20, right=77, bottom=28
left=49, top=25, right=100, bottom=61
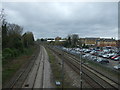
left=7, top=23, right=23, bottom=50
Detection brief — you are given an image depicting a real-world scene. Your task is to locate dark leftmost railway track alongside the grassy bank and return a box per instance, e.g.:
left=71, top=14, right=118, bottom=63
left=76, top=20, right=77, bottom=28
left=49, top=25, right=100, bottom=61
left=3, top=47, right=40, bottom=89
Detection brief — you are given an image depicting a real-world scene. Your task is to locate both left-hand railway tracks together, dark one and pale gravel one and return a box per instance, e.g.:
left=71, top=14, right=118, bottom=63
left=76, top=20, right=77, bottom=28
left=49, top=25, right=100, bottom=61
left=6, top=46, right=45, bottom=89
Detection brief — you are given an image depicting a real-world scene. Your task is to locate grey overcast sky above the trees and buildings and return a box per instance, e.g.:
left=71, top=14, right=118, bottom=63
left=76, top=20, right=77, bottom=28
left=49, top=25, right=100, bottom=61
left=2, top=2, right=118, bottom=38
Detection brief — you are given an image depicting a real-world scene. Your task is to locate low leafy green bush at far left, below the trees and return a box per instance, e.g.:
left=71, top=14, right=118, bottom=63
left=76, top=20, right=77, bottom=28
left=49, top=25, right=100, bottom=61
left=2, top=48, right=14, bottom=59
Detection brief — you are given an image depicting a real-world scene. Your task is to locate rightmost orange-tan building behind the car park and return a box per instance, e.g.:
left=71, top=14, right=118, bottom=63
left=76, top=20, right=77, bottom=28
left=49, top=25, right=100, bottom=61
left=96, top=38, right=117, bottom=47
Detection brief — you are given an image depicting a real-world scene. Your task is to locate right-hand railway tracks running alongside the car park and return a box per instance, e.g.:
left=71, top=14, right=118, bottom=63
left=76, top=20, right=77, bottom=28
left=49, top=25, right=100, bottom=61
left=47, top=45, right=119, bottom=90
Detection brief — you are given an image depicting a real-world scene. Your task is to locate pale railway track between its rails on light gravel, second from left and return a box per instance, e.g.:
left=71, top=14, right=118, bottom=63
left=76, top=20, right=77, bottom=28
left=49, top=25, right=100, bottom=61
left=22, top=46, right=45, bottom=89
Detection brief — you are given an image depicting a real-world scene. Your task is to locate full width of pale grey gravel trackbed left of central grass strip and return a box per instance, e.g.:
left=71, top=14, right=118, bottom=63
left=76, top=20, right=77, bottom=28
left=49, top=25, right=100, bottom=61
left=23, top=46, right=54, bottom=88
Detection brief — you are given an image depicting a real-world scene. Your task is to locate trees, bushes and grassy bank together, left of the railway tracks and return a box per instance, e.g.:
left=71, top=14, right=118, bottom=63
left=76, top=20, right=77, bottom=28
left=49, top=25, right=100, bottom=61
left=0, top=13, right=36, bottom=83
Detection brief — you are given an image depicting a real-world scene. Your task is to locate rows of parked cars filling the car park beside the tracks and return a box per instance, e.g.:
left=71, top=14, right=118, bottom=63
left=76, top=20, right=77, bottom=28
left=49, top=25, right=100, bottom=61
left=56, top=47, right=120, bottom=69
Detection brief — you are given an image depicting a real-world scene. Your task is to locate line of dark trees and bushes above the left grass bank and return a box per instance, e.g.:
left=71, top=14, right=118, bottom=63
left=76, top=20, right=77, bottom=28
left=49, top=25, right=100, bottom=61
left=2, top=21, right=34, bottom=60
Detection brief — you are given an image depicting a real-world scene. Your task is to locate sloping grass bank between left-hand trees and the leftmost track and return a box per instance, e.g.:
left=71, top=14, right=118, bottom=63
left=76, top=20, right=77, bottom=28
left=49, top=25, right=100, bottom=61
left=2, top=47, right=36, bottom=84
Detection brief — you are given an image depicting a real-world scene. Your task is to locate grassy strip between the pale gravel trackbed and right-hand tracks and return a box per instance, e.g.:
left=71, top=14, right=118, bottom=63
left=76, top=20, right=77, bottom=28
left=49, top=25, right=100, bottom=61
left=46, top=48, right=74, bottom=88
